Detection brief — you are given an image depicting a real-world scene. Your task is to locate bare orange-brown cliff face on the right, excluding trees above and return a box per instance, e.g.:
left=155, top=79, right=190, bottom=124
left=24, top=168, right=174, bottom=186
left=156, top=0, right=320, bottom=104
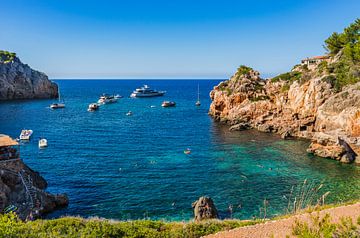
left=209, top=66, right=360, bottom=163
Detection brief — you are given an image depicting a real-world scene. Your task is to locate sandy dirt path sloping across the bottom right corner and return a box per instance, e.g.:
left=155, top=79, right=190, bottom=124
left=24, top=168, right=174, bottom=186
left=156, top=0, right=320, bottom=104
left=206, top=203, right=360, bottom=238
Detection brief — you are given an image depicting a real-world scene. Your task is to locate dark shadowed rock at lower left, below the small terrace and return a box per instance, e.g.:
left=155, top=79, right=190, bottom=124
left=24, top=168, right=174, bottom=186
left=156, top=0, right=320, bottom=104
left=0, top=159, right=69, bottom=220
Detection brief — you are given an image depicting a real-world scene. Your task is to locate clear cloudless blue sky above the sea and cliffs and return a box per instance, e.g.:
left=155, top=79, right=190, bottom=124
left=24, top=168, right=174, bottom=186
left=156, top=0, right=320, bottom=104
left=0, top=0, right=360, bottom=79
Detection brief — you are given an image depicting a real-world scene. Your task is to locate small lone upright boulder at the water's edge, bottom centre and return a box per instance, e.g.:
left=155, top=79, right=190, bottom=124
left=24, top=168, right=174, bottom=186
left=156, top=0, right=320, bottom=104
left=192, top=197, right=218, bottom=221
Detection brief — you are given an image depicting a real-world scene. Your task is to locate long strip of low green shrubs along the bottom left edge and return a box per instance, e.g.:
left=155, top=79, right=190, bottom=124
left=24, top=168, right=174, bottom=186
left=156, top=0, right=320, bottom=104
left=0, top=214, right=258, bottom=238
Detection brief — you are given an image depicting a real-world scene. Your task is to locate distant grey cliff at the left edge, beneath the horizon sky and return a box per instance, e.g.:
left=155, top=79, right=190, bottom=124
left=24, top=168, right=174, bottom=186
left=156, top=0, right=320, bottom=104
left=0, top=51, right=58, bottom=100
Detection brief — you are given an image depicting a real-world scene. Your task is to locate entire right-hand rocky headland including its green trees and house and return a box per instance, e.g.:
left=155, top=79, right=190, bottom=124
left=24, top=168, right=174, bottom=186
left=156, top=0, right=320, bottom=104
left=209, top=20, right=360, bottom=163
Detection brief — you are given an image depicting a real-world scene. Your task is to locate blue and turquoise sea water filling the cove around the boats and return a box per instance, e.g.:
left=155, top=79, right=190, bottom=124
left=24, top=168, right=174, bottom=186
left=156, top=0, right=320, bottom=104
left=0, top=80, right=360, bottom=220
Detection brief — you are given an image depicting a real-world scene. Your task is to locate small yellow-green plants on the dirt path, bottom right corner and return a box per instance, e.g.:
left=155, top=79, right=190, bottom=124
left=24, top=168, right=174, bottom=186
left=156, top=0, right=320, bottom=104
left=292, top=214, right=360, bottom=238
